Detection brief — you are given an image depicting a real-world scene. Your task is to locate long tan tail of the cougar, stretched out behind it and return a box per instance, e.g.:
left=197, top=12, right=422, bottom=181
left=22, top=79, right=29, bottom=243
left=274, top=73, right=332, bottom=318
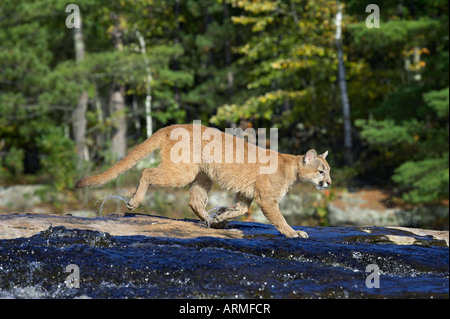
left=75, top=131, right=162, bottom=188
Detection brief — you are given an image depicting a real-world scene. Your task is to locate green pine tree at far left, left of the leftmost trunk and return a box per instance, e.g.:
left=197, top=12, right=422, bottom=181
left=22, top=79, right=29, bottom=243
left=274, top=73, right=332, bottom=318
left=0, top=0, right=81, bottom=190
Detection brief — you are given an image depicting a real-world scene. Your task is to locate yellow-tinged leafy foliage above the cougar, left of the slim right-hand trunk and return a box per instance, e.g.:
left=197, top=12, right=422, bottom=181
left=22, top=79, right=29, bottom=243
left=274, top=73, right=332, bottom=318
left=210, top=0, right=342, bottom=156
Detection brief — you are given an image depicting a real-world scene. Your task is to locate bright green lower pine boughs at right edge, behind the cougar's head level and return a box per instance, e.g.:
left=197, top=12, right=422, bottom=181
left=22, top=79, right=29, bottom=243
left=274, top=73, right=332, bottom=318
left=356, top=88, right=449, bottom=203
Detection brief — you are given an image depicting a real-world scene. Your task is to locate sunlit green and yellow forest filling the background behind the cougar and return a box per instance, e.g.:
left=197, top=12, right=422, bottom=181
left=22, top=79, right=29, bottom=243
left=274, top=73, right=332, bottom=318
left=0, top=0, right=449, bottom=209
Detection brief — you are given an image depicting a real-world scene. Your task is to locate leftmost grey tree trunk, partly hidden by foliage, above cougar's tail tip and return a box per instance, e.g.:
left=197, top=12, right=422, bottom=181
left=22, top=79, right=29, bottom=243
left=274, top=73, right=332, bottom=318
left=72, top=17, right=89, bottom=170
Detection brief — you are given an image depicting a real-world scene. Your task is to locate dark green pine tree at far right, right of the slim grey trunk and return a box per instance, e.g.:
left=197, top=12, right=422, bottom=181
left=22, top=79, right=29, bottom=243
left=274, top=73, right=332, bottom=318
left=349, top=1, right=449, bottom=203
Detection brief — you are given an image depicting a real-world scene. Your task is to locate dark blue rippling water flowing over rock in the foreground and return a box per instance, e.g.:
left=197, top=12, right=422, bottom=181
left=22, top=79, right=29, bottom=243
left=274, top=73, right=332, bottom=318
left=0, top=222, right=449, bottom=298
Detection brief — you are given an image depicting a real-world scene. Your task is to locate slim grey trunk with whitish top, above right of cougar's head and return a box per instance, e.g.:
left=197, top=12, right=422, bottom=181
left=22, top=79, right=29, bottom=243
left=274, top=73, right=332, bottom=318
left=336, top=4, right=353, bottom=165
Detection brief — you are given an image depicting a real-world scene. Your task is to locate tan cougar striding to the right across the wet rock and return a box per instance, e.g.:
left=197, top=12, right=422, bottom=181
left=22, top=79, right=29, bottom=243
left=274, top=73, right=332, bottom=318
left=75, top=125, right=331, bottom=238
